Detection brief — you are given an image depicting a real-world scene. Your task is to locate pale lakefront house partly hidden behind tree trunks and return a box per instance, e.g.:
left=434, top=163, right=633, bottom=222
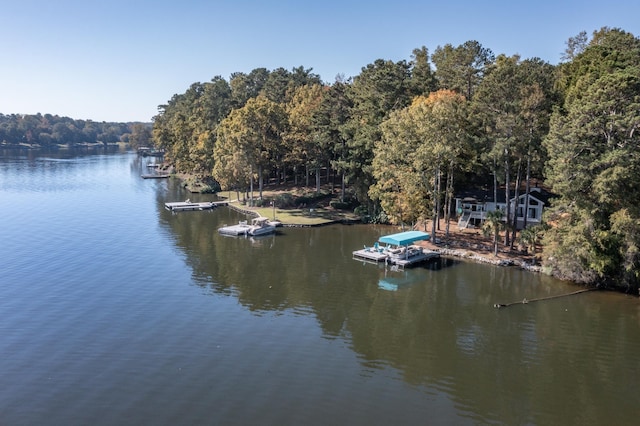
left=455, top=187, right=551, bottom=229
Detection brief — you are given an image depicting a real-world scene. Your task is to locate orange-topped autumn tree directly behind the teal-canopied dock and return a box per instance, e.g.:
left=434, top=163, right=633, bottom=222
left=370, top=90, right=470, bottom=238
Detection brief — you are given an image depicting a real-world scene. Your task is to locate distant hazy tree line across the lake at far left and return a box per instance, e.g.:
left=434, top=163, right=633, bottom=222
left=0, top=113, right=152, bottom=147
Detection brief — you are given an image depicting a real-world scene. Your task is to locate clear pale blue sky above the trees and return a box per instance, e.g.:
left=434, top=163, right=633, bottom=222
left=0, top=0, right=640, bottom=122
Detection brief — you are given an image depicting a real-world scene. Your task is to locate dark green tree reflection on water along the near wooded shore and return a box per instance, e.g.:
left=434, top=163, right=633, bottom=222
left=149, top=156, right=640, bottom=424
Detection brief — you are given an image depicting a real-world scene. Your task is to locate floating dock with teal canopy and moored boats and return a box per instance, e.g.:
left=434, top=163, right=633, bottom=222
left=353, top=231, right=440, bottom=269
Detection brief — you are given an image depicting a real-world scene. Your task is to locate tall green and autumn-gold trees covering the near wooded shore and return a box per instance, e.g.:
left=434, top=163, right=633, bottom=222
left=153, top=27, right=640, bottom=292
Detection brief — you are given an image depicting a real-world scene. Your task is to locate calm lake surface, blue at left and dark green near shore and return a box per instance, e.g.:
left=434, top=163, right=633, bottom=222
left=0, top=151, right=640, bottom=425
